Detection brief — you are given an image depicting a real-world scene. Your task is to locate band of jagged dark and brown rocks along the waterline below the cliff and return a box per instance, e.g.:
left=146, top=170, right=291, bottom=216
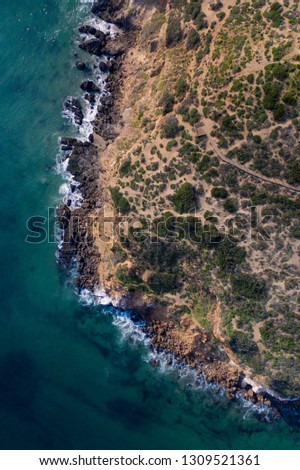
left=57, top=0, right=300, bottom=422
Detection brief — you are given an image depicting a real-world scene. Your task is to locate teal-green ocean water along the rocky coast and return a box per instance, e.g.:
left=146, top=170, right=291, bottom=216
left=0, top=0, right=300, bottom=450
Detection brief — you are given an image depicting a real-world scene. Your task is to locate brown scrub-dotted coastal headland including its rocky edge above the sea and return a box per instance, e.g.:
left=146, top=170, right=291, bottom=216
left=58, top=0, right=300, bottom=418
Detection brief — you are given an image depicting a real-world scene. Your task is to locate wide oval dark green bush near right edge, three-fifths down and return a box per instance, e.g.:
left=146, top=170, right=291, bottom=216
left=232, top=274, right=267, bottom=300
